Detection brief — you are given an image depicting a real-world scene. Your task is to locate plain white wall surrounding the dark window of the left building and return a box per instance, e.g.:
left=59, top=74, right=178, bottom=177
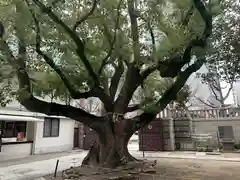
left=33, top=118, right=74, bottom=154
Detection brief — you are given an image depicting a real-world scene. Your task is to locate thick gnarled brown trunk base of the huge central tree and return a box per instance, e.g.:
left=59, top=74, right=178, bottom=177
left=82, top=120, right=136, bottom=168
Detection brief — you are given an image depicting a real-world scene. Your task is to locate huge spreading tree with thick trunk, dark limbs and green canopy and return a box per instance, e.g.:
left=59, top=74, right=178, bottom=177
left=0, top=0, right=216, bottom=167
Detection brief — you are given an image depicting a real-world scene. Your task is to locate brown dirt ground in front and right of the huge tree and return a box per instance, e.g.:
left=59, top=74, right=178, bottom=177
left=45, top=158, right=240, bottom=180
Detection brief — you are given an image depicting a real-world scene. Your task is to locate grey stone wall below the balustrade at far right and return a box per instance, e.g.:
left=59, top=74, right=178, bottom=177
left=193, top=119, right=240, bottom=147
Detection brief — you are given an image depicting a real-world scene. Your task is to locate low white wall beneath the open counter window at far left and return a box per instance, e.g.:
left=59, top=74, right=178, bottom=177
left=0, top=143, right=32, bottom=161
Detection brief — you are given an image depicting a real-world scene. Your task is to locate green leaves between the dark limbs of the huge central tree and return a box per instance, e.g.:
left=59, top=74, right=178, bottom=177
left=0, top=0, right=217, bottom=108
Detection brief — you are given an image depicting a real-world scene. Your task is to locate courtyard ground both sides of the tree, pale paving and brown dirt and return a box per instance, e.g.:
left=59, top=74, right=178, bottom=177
left=0, top=150, right=240, bottom=180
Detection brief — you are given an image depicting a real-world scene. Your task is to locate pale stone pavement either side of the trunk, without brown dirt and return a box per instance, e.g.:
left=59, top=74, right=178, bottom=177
left=0, top=150, right=240, bottom=180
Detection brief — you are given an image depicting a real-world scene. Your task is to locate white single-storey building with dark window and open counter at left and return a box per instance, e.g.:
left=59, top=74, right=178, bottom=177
left=0, top=102, right=75, bottom=160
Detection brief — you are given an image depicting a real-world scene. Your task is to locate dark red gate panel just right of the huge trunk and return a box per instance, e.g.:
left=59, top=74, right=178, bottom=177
left=139, top=119, right=164, bottom=151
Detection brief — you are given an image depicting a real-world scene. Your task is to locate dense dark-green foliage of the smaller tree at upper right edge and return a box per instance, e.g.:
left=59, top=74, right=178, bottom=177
left=205, top=0, right=240, bottom=83
